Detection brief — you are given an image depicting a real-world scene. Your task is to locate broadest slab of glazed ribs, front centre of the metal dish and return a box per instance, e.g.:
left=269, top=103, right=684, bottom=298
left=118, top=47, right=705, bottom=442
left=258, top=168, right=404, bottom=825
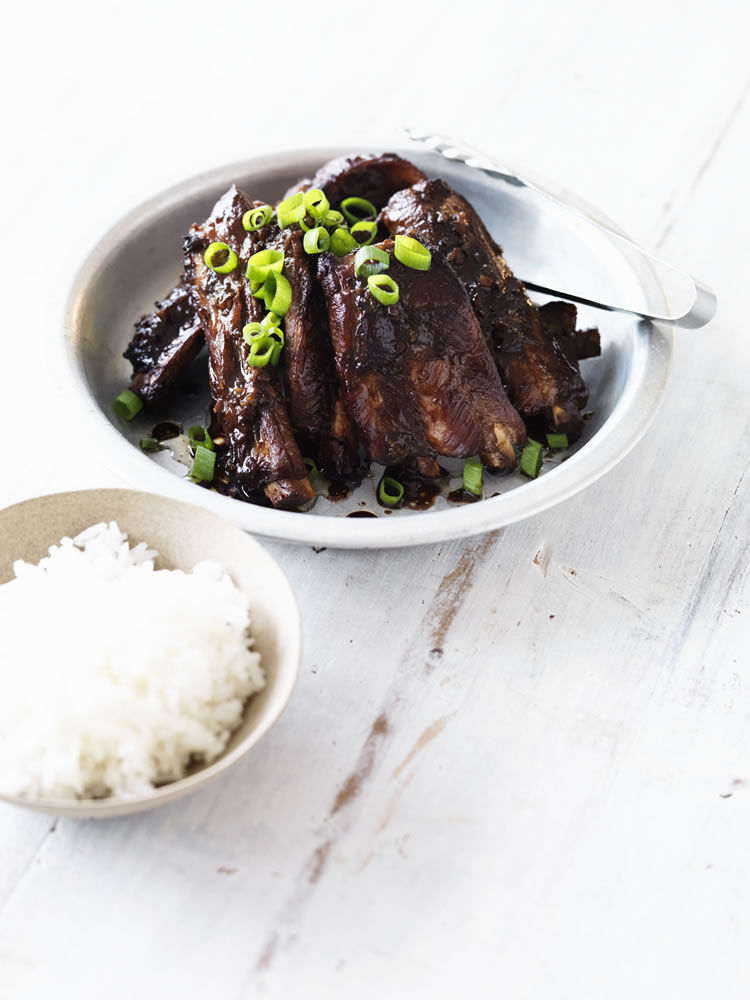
left=319, top=240, right=525, bottom=473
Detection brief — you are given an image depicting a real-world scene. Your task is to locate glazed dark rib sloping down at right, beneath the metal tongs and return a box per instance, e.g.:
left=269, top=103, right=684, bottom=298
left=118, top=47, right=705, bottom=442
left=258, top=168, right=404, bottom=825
left=383, top=180, right=587, bottom=433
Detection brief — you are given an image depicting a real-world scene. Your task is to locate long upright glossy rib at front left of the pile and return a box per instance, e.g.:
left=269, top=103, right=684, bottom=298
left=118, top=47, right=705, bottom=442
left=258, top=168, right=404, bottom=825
left=185, top=187, right=315, bottom=508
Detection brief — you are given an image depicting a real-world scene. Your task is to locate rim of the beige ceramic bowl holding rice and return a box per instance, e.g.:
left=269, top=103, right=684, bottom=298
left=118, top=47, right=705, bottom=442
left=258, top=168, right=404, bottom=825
left=0, top=487, right=302, bottom=819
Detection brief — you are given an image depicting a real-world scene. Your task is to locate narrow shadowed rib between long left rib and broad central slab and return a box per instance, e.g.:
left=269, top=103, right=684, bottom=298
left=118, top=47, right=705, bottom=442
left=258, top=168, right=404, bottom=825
left=241, top=205, right=359, bottom=479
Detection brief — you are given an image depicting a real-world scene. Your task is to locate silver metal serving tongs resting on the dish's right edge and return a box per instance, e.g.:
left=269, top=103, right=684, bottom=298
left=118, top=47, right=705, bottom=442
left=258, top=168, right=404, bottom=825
left=405, top=128, right=716, bottom=330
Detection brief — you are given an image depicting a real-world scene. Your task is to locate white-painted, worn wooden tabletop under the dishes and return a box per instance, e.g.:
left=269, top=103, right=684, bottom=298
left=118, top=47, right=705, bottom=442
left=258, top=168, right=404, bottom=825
left=0, top=0, right=750, bottom=1000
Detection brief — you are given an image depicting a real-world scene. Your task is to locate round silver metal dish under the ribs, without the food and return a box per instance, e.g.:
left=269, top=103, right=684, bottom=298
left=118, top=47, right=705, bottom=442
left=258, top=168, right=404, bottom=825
left=65, top=148, right=672, bottom=548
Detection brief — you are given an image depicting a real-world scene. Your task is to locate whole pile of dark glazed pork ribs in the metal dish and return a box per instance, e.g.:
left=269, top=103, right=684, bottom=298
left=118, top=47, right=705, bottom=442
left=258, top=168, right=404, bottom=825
left=125, top=153, right=600, bottom=509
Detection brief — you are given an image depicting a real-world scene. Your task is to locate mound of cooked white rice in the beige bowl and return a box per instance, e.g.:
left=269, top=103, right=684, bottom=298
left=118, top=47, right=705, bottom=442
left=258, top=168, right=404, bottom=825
left=0, top=521, right=265, bottom=798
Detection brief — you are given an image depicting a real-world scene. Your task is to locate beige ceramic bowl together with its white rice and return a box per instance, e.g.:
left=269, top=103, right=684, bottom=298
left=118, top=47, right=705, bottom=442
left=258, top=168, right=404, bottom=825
left=0, top=489, right=300, bottom=817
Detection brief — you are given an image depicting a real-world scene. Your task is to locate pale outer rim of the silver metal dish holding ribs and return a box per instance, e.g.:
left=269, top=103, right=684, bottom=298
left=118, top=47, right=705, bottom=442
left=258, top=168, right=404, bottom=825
left=58, top=143, right=673, bottom=548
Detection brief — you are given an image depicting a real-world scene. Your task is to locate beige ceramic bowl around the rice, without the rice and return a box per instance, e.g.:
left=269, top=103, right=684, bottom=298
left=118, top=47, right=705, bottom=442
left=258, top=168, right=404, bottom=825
left=0, top=490, right=300, bottom=817
